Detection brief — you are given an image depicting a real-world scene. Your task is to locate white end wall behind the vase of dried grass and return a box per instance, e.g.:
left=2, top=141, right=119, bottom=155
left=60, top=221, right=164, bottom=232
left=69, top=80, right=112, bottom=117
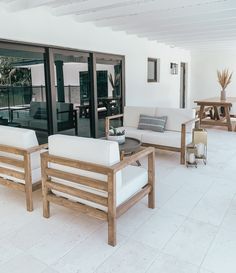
left=191, top=49, right=236, bottom=105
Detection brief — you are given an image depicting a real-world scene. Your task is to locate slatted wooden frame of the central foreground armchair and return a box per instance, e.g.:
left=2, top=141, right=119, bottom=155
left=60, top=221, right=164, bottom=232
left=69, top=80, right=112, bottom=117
left=41, top=147, right=155, bottom=246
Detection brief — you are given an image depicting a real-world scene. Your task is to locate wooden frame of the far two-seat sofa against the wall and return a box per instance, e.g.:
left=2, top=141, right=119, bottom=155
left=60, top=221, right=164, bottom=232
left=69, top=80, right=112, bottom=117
left=105, top=114, right=199, bottom=164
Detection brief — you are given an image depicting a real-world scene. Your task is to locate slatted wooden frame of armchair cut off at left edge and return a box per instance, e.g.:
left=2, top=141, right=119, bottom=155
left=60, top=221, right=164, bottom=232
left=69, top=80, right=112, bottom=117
left=0, top=144, right=47, bottom=211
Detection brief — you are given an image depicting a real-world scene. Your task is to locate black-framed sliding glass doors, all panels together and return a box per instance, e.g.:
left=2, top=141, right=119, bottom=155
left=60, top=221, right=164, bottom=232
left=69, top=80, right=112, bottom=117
left=0, top=41, right=125, bottom=140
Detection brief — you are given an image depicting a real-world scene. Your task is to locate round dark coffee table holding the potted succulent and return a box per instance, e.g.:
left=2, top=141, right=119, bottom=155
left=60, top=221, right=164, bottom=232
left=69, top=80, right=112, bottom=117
left=119, top=137, right=142, bottom=166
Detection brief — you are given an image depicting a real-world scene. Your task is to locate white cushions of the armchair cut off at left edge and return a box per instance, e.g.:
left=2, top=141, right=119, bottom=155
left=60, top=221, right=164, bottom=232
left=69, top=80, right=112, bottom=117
left=0, top=126, right=41, bottom=183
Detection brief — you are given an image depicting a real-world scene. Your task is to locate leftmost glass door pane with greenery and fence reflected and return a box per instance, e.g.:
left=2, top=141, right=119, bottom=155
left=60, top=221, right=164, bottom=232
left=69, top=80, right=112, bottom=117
left=0, top=46, right=48, bottom=143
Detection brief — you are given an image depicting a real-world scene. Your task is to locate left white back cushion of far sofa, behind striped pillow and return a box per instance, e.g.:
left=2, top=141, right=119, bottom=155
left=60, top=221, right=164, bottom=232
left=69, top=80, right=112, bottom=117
left=124, top=106, right=155, bottom=128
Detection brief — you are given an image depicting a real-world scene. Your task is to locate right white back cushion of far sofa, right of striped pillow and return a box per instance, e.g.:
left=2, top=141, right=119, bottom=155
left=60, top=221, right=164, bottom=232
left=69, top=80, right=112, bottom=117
left=155, top=107, right=196, bottom=132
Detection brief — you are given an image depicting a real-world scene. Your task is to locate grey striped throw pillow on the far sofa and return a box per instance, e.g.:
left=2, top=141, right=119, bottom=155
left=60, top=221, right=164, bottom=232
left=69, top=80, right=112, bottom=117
left=138, top=114, right=167, bottom=132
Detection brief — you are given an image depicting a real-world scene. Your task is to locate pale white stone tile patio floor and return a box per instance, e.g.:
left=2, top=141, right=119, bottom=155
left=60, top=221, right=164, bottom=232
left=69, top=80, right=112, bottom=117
left=0, top=129, right=236, bottom=273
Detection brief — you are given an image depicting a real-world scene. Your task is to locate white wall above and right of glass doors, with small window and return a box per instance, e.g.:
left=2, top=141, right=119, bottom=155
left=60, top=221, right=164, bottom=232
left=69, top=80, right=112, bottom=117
left=0, top=4, right=191, bottom=107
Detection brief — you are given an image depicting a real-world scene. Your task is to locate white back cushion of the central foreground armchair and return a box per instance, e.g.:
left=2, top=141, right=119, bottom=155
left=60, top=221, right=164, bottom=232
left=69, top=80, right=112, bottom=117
left=48, top=134, right=122, bottom=188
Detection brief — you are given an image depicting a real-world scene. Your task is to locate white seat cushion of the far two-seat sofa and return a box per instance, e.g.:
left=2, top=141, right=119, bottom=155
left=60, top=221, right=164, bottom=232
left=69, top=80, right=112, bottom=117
left=141, top=130, right=191, bottom=148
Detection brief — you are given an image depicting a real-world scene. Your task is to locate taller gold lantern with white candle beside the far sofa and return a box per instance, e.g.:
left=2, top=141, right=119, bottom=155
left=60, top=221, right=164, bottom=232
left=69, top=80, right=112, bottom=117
left=193, top=129, right=207, bottom=165
